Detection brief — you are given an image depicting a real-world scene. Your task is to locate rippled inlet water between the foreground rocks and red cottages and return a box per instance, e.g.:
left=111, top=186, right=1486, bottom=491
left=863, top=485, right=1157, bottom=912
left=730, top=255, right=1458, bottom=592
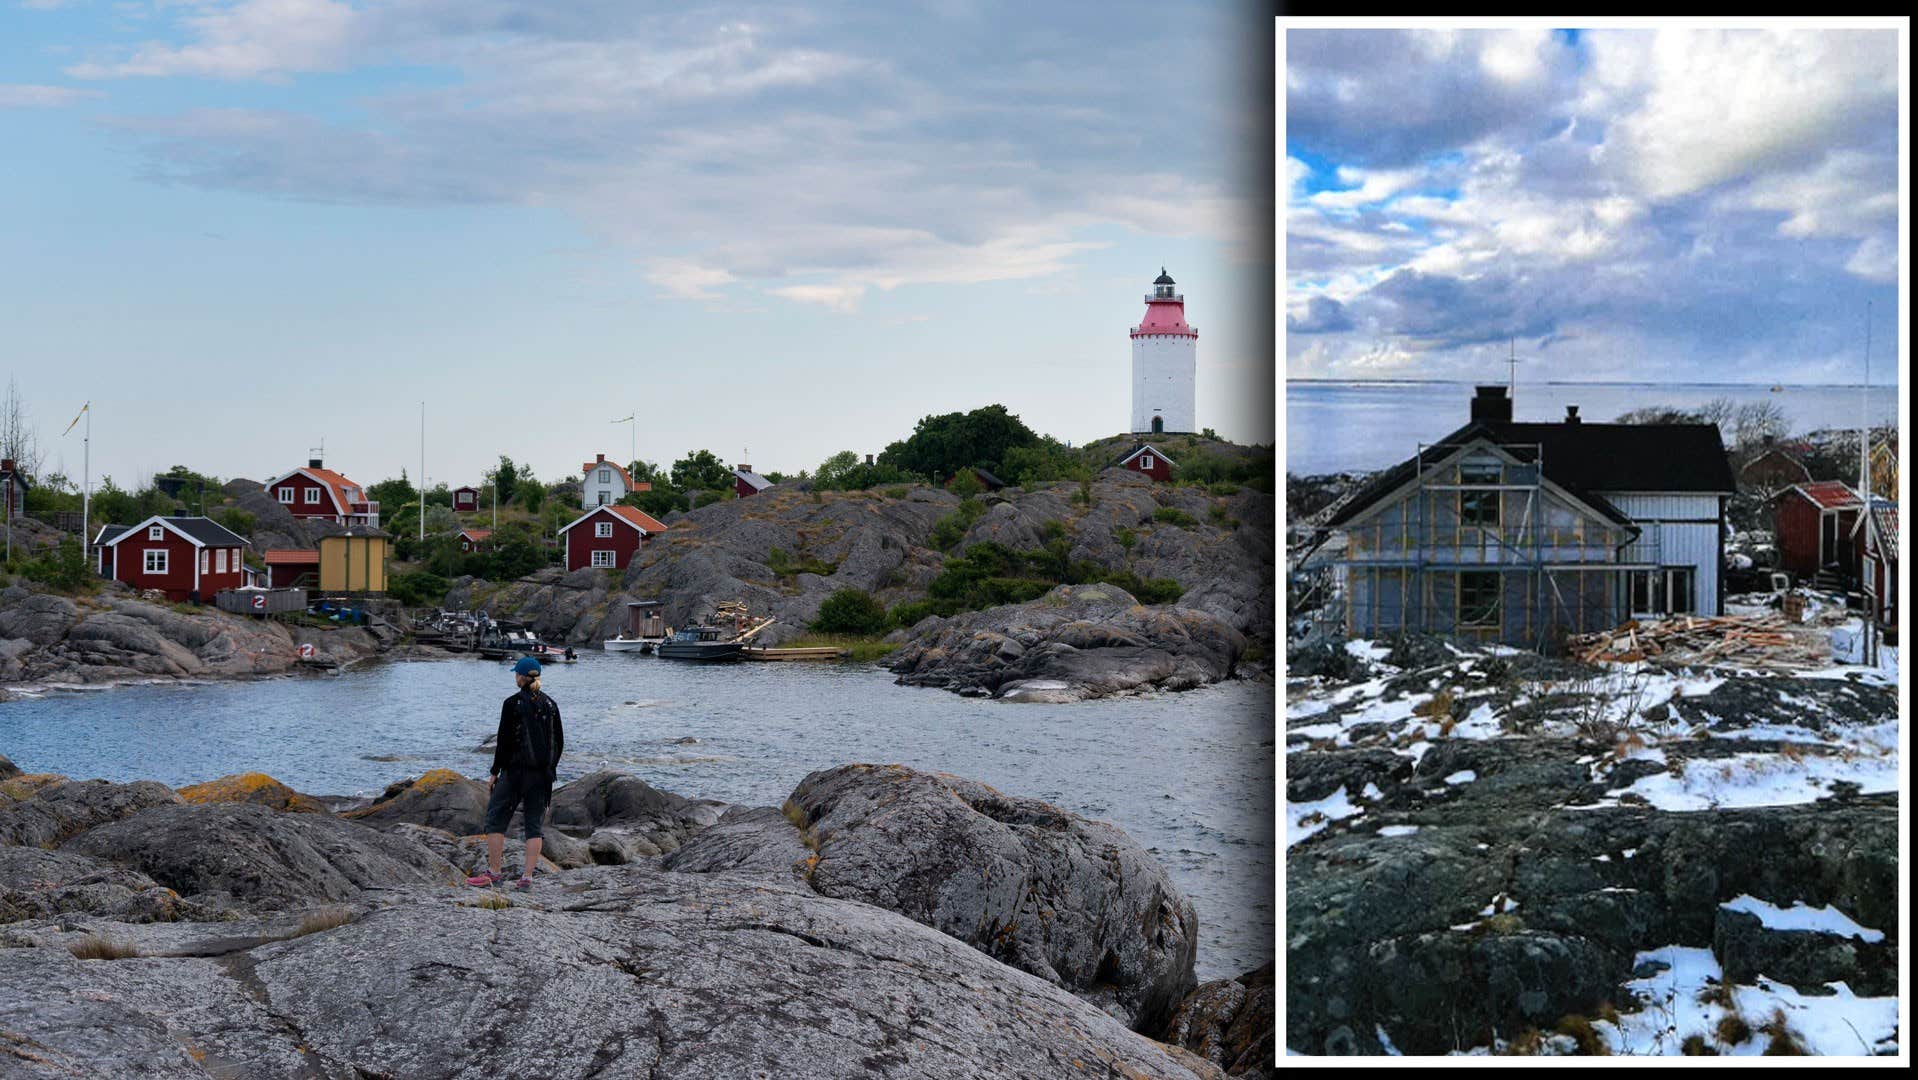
left=0, top=652, right=1274, bottom=978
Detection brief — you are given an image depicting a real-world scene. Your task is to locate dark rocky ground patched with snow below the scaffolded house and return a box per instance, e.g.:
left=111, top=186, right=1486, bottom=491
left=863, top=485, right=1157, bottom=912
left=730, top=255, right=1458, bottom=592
left=1285, top=637, right=1901, bottom=1055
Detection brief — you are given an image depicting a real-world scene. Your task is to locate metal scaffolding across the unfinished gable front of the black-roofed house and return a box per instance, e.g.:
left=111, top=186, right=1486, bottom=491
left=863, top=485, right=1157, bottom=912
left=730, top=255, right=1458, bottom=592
left=1322, top=443, right=1659, bottom=650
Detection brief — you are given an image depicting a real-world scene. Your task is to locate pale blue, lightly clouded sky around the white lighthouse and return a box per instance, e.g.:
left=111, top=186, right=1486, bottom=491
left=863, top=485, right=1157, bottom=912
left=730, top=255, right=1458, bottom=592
left=0, top=0, right=1275, bottom=485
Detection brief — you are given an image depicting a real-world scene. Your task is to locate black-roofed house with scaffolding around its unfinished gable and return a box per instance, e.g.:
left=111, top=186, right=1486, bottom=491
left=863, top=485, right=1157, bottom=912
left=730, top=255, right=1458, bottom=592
left=1304, top=386, right=1734, bottom=650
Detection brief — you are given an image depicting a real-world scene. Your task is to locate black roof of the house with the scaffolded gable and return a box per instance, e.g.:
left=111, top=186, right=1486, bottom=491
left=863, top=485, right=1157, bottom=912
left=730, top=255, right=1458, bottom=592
left=1325, top=420, right=1738, bottom=526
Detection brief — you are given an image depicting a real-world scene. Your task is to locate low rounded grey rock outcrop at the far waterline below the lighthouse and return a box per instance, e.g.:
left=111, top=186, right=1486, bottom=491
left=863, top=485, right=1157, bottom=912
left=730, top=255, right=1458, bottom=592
left=890, top=585, right=1245, bottom=702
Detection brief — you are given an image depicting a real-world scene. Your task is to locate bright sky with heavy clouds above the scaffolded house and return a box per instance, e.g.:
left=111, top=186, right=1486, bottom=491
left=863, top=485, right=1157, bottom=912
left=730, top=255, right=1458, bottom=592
left=1279, top=29, right=1901, bottom=384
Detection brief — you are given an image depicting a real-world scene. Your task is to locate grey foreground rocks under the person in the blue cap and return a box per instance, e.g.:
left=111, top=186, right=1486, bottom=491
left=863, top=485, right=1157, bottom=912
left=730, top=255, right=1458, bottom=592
left=0, top=758, right=1275, bottom=1078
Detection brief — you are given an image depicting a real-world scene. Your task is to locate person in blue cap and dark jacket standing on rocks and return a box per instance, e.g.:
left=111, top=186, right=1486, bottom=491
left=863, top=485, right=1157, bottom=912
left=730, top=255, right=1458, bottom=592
left=466, top=656, right=566, bottom=888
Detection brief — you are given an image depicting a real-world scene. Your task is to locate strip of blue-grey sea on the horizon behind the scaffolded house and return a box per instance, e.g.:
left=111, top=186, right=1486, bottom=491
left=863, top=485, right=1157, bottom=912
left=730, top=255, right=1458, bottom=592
left=1285, top=380, right=1899, bottom=476
